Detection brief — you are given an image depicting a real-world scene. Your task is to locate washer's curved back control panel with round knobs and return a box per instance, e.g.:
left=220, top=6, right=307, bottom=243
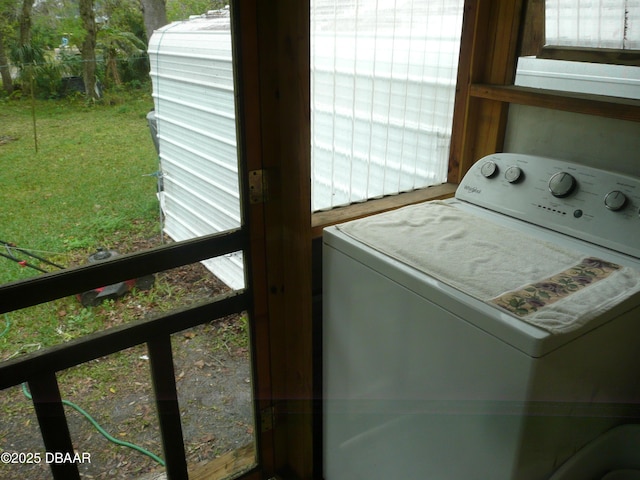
left=456, top=153, right=640, bottom=258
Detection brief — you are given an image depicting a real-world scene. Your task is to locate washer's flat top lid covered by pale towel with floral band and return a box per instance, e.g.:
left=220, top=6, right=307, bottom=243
left=337, top=201, right=640, bottom=334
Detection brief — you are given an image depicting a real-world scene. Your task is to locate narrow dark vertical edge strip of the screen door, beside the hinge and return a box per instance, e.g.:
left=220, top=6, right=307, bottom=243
left=232, top=0, right=277, bottom=477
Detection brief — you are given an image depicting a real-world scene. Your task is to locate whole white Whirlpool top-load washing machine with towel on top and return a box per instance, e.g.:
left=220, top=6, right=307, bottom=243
left=323, top=154, right=640, bottom=480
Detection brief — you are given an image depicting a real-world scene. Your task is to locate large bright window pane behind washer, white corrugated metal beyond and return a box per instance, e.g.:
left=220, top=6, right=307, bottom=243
left=311, top=0, right=463, bottom=210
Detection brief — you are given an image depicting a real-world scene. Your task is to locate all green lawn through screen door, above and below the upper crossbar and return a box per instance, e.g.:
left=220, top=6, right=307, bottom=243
left=0, top=84, right=246, bottom=374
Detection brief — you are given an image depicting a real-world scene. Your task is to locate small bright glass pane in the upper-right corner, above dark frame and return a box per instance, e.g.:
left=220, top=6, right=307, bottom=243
left=545, top=0, right=640, bottom=49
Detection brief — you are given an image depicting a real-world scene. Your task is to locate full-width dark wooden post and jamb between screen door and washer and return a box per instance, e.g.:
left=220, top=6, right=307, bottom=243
left=238, top=0, right=314, bottom=478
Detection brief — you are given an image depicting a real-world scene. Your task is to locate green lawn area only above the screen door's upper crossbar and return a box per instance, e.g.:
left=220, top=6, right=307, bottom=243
left=0, top=87, right=160, bottom=283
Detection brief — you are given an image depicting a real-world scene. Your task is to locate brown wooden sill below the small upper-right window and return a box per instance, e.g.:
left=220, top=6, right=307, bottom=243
left=469, top=84, right=640, bottom=122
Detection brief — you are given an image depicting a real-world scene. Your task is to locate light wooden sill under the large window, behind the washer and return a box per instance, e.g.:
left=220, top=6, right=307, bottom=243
left=311, top=183, right=457, bottom=238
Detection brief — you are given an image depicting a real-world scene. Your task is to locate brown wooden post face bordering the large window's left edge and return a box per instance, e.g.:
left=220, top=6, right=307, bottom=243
left=261, top=0, right=316, bottom=479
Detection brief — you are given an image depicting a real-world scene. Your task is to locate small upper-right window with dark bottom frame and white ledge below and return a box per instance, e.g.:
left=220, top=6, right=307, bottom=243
left=515, top=0, right=640, bottom=99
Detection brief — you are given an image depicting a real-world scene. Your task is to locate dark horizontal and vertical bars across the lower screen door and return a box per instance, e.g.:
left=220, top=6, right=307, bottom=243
left=0, top=229, right=251, bottom=480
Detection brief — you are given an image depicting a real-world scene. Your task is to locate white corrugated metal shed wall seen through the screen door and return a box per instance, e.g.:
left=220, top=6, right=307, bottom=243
left=149, top=11, right=244, bottom=288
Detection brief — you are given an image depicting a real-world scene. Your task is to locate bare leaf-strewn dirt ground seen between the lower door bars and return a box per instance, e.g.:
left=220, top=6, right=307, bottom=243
left=0, top=249, right=254, bottom=480
